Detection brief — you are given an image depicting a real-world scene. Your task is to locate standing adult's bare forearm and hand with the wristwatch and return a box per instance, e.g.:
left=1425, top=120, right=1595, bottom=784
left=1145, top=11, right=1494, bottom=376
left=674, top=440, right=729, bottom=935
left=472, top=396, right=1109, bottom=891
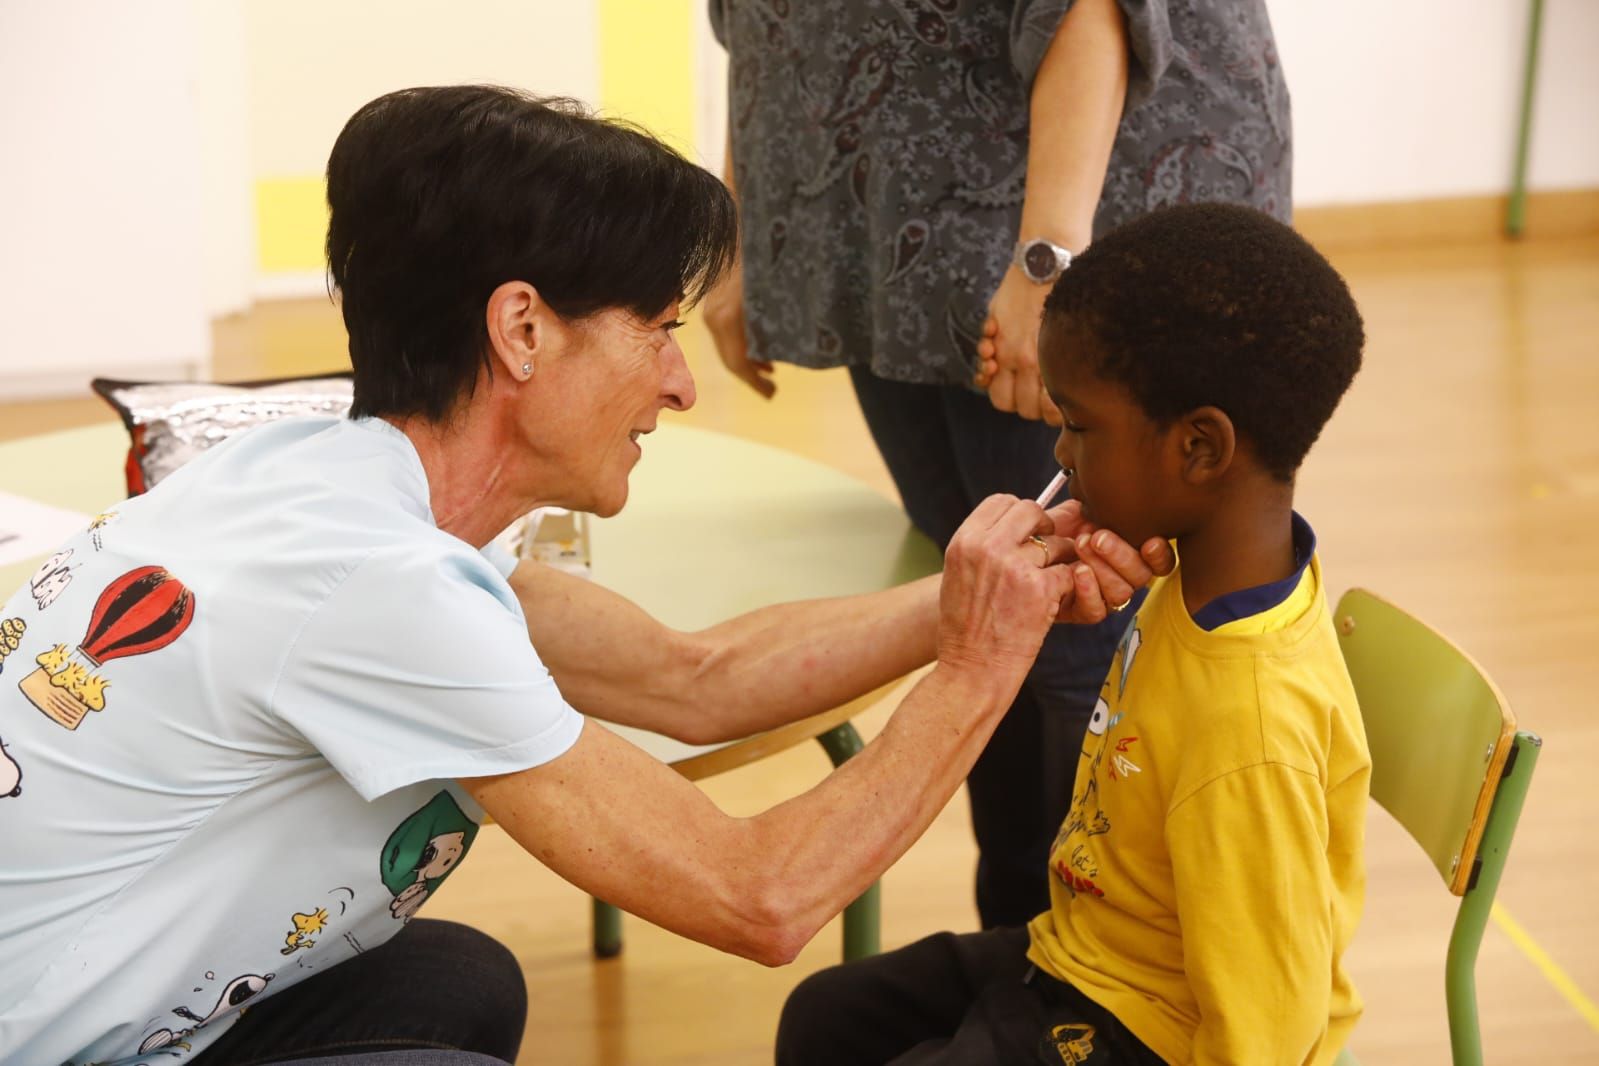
left=979, top=0, right=1129, bottom=425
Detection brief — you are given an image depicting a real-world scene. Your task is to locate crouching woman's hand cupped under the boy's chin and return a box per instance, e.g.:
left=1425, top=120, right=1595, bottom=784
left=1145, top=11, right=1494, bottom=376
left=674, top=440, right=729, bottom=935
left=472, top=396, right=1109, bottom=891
left=1044, top=500, right=1177, bottom=625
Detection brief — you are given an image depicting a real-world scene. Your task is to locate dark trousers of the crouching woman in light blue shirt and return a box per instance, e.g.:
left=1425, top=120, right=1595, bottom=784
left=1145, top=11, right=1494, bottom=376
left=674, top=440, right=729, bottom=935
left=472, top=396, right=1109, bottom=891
left=193, top=919, right=528, bottom=1066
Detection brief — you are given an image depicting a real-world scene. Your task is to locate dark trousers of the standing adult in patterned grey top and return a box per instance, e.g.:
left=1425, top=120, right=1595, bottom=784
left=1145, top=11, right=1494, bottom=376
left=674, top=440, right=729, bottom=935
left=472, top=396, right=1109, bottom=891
left=849, top=366, right=1134, bottom=929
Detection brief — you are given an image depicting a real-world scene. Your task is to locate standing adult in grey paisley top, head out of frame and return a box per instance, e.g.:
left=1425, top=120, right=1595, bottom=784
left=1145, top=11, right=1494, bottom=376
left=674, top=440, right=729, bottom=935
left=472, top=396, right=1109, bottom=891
left=705, top=0, right=1290, bottom=927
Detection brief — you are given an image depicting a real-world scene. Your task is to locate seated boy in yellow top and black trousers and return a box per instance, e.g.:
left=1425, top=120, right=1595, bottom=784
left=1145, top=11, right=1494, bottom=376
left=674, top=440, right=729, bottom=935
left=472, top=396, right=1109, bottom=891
left=777, top=205, right=1370, bottom=1066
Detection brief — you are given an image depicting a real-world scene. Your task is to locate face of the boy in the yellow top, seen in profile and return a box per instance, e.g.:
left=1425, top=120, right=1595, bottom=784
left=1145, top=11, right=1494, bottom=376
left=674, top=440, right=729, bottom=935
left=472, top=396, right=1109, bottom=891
left=1038, top=315, right=1185, bottom=543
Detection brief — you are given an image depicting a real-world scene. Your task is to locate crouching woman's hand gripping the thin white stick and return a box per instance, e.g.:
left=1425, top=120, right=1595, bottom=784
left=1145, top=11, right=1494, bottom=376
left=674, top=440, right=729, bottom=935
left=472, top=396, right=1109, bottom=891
left=939, top=495, right=1073, bottom=678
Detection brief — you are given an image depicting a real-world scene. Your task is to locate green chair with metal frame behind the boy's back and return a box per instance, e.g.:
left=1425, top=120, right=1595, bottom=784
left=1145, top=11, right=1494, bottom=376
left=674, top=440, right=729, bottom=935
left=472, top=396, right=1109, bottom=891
left=1334, top=588, right=1543, bottom=1066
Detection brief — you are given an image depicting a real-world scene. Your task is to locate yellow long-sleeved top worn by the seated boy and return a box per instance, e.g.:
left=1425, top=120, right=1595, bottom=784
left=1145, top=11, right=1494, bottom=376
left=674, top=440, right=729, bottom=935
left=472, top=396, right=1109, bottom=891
left=1028, top=558, right=1370, bottom=1066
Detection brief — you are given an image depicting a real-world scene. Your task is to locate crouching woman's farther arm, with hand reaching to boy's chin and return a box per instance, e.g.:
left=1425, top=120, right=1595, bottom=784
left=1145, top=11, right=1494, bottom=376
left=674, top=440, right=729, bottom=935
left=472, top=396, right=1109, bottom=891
left=510, top=500, right=1174, bottom=743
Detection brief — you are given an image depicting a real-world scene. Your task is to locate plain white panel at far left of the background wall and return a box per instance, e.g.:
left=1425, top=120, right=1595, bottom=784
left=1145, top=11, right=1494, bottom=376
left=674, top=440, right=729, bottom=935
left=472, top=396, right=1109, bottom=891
left=0, top=0, right=209, bottom=400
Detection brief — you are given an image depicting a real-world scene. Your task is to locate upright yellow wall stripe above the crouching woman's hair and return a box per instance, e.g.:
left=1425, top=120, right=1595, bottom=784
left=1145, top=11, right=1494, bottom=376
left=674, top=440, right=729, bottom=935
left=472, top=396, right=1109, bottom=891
left=600, top=0, right=705, bottom=160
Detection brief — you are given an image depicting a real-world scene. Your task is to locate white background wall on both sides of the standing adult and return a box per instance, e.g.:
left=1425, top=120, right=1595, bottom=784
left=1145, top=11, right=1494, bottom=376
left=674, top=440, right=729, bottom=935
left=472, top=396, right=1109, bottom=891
left=0, top=0, right=1599, bottom=398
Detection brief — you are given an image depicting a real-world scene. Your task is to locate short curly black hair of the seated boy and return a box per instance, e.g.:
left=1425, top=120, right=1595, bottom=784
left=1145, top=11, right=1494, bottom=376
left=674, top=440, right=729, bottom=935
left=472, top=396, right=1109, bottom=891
left=1039, top=203, right=1366, bottom=481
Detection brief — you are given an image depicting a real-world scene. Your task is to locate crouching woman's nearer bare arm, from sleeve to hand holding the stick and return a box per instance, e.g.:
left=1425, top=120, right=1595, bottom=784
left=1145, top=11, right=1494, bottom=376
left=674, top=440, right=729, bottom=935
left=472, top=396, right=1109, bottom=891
left=462, top=497, right=1073, bottom=965
